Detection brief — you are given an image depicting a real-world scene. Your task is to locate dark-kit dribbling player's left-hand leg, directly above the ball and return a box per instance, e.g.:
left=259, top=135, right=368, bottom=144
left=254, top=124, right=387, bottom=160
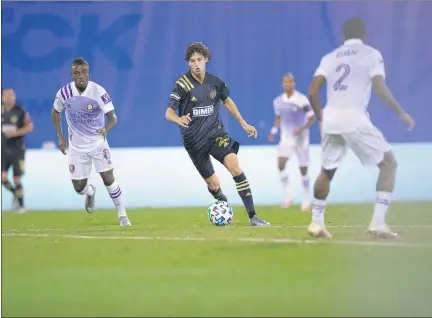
left=189, top=145, right=228, bottom=202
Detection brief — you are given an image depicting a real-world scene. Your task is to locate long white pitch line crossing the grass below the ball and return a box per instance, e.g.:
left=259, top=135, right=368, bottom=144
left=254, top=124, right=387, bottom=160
left=2, top=233, right=432, bottom=248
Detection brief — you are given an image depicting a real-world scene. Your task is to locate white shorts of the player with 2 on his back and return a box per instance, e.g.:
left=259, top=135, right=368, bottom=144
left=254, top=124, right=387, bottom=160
left=321, top=125, right=391, bottom=170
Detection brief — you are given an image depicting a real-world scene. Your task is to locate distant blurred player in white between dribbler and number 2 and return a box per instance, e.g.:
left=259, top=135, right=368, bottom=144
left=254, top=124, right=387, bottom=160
left=269, top=73, right=315, bottom=211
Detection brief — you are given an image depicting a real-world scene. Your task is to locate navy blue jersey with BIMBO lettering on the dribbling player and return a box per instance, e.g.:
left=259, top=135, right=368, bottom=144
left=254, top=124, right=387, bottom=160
left=169, top=71, right=230, bottom=151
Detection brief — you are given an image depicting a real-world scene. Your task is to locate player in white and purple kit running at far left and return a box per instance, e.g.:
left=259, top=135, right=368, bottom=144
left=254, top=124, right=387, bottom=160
left=52, top=58, right=131, bottom=226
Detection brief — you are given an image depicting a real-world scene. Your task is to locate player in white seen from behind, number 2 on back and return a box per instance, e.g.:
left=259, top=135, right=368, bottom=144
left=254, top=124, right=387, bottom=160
left=308, top=18, right=414, bottom=238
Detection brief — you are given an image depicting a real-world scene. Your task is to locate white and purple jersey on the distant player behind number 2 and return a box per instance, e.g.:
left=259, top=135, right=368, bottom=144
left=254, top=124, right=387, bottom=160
left=273, top=91, right=314, bottom=139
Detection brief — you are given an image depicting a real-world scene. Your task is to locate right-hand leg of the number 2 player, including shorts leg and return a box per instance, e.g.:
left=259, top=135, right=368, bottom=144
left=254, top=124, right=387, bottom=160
left=346, top=126, right=398, bottom=238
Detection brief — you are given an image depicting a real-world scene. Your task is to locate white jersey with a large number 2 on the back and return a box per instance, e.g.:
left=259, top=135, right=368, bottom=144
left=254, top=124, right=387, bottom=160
left=315, top=39, right=385, bottom=134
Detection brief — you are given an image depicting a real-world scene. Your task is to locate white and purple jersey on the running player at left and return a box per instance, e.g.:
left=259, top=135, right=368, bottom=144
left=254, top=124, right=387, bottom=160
left=53, top=81, right=114, bottom=151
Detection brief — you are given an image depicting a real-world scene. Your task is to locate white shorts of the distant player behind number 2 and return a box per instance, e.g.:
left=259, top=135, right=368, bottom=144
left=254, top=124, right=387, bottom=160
left=278, top=136, right=309, bottom=167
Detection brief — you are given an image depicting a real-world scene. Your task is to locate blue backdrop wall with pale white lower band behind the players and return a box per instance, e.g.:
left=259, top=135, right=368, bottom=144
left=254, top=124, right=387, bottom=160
left=2, top=2, right=432, bottom=209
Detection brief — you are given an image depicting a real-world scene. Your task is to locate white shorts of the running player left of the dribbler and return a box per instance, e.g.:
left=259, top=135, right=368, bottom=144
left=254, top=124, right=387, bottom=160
left=68, top=140, right=114, bottom=180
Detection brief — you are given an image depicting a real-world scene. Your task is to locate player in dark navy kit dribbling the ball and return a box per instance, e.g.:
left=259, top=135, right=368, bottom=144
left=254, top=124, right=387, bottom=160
left=166, top=43, right=269, bottom=226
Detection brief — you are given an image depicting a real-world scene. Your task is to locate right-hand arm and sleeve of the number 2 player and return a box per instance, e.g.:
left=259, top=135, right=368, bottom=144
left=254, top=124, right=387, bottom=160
left=370, top=53, right=414, bottom=130
